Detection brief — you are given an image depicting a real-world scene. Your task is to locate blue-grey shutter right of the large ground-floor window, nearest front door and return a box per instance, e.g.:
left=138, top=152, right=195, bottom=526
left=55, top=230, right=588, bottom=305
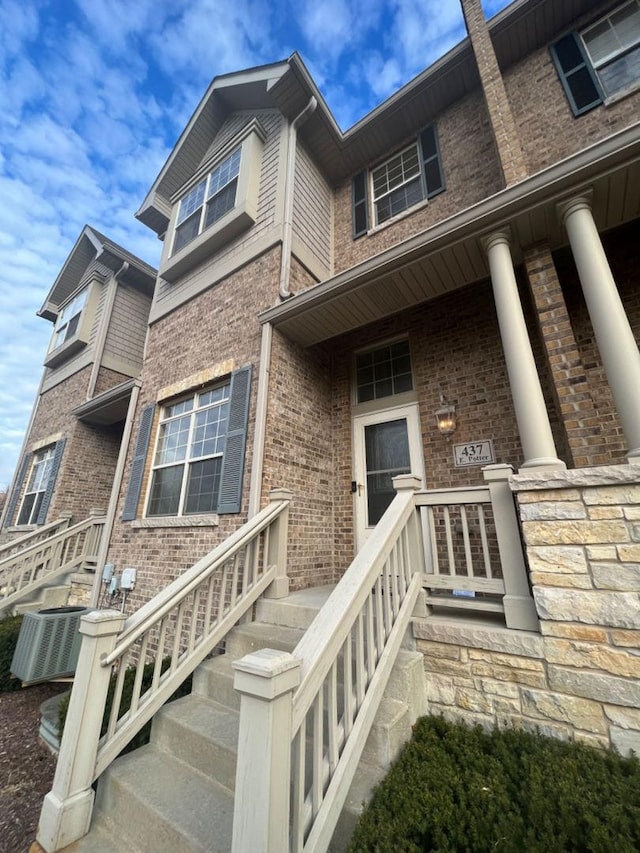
left=218, top=366, right=251, bottom=515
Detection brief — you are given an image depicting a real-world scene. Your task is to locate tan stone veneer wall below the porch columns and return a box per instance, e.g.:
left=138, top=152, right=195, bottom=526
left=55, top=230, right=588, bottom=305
left=414, top=465, right=640, bottom=754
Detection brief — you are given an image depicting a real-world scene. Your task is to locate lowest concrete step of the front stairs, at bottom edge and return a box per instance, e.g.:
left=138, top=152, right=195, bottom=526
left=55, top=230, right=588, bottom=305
left=86, top=744, right=233, bottom=853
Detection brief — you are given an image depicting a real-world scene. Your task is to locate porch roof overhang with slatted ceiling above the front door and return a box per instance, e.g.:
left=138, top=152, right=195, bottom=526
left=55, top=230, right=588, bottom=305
left=261, top=124, right=640, bottom=346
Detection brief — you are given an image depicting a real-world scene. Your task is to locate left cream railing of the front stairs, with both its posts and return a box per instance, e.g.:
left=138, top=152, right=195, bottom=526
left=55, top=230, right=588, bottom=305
left=38, top=489, right=291, bottom=853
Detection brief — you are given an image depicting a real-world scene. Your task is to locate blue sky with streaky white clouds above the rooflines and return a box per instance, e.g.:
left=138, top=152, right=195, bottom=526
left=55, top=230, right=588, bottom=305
left=0, top=0, right=507, bottom=487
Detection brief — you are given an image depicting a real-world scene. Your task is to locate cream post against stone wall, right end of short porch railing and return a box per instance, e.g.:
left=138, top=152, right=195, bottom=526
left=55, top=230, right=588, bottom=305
left=482, top=465, right=539, bottom=631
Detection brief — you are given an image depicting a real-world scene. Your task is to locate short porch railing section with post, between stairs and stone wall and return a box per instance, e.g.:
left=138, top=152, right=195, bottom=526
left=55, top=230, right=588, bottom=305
left=416, top=465, right=538, bottom=630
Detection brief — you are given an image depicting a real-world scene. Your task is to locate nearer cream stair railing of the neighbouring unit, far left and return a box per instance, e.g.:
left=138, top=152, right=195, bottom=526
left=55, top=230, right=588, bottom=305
left=0, top=516, right=105, bottom=612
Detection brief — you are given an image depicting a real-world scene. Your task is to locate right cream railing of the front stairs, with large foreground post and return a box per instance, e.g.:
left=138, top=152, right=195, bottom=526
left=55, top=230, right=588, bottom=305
left=232, top=475, right=424, bottom=853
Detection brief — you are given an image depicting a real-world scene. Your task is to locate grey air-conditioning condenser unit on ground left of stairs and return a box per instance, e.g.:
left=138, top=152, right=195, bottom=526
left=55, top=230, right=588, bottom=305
left=11, top=607, right=91, bottom=684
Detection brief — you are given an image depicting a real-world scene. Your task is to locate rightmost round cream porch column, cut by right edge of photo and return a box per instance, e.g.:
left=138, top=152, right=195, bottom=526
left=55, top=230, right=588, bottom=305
left=559, top=194, right=640, bottom=462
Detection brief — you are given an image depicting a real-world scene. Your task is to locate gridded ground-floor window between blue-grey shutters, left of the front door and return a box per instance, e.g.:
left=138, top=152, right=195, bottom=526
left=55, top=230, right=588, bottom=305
left=147, top=383, right=230, bottom=516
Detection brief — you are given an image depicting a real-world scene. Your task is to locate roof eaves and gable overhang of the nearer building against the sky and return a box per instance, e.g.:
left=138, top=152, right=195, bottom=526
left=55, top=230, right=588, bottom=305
left=136, top=0, right=593, bottom=235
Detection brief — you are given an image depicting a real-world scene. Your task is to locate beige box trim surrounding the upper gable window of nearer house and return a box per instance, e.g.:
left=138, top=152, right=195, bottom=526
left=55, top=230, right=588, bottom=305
left=158, top=119, right=266, bottom=282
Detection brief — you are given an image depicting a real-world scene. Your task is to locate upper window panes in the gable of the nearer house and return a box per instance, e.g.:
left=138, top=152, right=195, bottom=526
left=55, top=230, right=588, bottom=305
left=173, top=148, right=242, bottom=254
